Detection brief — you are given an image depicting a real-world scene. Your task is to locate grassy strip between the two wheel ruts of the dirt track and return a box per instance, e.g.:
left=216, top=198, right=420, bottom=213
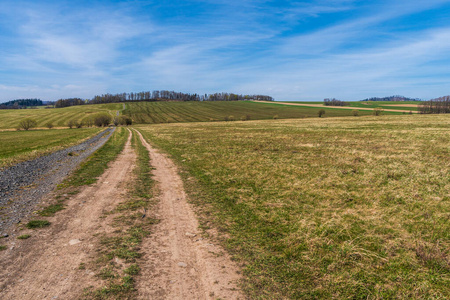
left=80, top=129, right=157, bottom=299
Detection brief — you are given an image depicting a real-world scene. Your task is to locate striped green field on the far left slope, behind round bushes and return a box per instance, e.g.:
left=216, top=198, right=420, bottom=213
left=0, top=103, right=123, bottom=130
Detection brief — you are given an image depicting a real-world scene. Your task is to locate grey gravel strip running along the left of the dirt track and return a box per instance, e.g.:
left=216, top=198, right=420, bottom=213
left=0, top=128, right=114, bottom=235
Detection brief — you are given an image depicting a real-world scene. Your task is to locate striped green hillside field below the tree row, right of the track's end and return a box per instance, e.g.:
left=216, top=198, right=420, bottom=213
left=123, top=101, right=380, bottom=124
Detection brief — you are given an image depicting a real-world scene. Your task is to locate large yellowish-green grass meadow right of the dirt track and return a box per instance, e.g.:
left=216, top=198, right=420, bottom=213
left=137, top=115, right=450, bottom=299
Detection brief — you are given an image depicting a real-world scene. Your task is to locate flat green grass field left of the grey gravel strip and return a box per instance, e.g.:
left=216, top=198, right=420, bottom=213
left=0, top=128, right=102, bottom=168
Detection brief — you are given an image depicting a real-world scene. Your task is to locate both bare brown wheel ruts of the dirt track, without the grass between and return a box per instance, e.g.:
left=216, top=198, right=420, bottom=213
left=0, top=129, right=244, bottom=299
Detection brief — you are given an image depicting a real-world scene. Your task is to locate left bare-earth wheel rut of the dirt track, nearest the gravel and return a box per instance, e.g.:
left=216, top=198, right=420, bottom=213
left=0, top=130, right=136, bottom=299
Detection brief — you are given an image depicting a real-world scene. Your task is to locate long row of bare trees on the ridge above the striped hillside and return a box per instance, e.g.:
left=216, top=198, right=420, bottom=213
left=55, top=90, right=274, bottom=107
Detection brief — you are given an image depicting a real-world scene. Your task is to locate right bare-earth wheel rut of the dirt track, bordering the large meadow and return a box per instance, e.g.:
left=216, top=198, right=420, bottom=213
left=137, top=133, right=243, bottom=299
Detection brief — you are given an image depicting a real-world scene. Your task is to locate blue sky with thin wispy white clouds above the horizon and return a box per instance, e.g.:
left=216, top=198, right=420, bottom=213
left=0, top=0, right=450, bottom=102
